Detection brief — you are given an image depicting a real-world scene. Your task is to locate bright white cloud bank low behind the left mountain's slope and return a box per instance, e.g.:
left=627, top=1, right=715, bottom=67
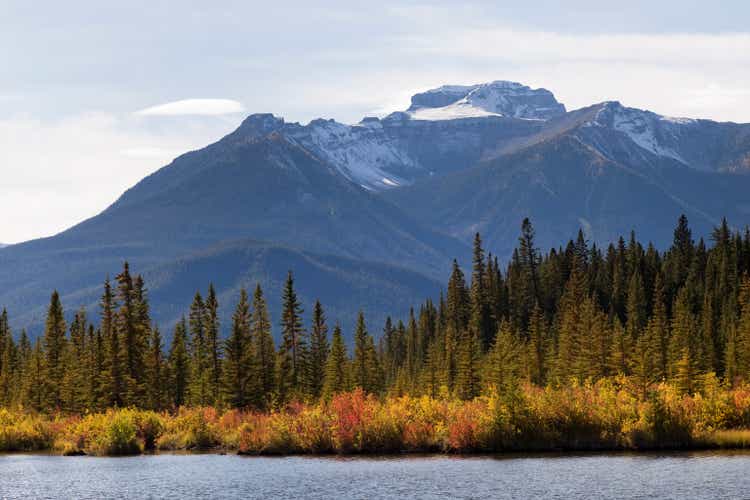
left=0, top=113, right=235, bottom=243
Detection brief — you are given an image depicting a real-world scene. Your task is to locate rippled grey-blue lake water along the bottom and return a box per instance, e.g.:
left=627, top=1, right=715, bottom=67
left=0, top=452, right=750, bottom=499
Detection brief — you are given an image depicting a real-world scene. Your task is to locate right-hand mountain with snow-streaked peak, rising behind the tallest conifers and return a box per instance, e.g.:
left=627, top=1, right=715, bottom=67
left=386, top=102, right=750, bottom=255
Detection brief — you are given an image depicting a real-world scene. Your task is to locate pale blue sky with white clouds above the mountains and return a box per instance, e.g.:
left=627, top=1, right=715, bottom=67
left=0, top=0, right=750, bottom=243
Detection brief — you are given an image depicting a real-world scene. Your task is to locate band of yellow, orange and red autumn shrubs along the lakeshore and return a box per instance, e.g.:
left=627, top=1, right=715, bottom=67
left=0, top=377, right=750, bottom=456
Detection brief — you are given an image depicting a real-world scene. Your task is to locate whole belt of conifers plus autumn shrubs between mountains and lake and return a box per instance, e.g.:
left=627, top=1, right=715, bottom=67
left=0, top=216, right=750, bottom=453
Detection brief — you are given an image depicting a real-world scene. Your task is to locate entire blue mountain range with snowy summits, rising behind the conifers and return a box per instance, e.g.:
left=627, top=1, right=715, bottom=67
left=0, top=81, right=750, bottom=338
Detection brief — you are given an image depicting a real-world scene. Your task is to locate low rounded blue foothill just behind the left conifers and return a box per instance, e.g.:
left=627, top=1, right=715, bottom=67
left=22, top=240, right=441, bottom=336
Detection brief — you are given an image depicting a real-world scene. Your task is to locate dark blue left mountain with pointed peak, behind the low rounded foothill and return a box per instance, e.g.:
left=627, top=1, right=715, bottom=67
left=0, top=128, right=466, bottom=338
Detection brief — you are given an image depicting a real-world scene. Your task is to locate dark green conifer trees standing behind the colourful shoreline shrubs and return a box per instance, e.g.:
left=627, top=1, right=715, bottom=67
left=0, top=216, right=750, bottom=413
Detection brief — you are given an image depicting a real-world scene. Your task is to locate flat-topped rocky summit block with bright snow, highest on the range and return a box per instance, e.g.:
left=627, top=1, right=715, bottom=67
left=407, top=80, right=565, bottom=120
